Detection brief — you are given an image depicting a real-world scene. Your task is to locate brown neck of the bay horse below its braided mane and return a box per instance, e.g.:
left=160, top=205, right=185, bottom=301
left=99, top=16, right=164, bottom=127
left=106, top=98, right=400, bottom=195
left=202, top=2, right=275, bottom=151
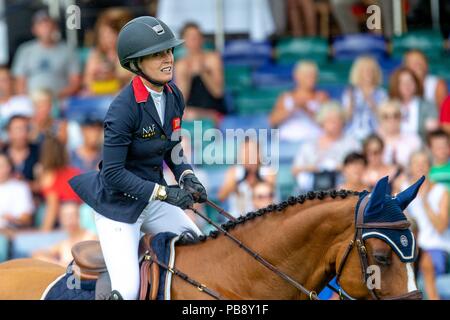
left=181, top=197, right=356, bottom=299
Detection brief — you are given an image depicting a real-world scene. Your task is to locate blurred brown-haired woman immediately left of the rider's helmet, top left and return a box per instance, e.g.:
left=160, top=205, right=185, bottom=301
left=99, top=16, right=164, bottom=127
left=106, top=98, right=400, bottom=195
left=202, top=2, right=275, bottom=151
left=83, top=8, right=132, bottom=95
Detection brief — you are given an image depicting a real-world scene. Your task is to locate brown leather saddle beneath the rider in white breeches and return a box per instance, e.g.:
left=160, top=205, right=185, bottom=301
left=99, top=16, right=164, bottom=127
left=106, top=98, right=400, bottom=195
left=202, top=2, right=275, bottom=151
left=72, top=234, right=160, bottom=300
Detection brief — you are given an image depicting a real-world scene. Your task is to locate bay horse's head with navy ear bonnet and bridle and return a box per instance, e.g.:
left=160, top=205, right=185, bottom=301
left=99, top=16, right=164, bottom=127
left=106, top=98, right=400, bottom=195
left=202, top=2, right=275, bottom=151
left=336, top=177, right=425, bottom=299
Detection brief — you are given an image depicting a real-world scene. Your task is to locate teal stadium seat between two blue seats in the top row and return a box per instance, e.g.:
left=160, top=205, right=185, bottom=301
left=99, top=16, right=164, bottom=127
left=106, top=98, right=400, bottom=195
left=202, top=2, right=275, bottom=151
left=275, top=37, right=329, bottom=64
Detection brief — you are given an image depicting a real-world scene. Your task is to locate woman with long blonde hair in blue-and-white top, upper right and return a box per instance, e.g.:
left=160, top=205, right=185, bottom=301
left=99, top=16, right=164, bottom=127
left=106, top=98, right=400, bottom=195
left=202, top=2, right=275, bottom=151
left=342, top=56, right=387, bottom=141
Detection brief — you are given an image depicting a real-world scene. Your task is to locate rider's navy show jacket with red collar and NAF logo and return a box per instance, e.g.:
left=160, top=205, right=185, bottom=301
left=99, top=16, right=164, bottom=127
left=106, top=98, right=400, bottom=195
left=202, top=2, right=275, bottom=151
left=69, top=77, right=192, bottom=223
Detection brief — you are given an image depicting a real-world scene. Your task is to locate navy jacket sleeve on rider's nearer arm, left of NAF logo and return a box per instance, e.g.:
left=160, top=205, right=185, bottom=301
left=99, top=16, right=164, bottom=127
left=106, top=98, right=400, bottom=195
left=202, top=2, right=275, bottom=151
left=102, top=96, right=156, bottom=199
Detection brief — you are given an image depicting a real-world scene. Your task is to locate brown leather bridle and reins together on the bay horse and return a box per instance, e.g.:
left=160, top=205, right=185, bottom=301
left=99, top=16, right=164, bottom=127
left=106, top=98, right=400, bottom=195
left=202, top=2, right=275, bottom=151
left=168, top=194, right=422, bottom=300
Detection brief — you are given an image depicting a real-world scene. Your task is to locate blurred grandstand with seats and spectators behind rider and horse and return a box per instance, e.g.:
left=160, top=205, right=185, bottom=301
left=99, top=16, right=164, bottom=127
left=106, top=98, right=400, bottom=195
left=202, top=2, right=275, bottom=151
left=0, top=0, right=450, bottom=299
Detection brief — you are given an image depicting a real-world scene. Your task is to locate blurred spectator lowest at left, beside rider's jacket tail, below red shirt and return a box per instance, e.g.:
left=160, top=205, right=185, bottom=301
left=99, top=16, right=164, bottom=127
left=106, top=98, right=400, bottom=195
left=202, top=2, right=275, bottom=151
left=33, top=202, right=97, bottom=267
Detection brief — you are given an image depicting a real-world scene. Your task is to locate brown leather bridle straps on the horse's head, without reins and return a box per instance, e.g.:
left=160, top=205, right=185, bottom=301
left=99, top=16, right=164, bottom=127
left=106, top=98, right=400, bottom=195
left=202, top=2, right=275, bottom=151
left=332, top=195, right=422, bottom=300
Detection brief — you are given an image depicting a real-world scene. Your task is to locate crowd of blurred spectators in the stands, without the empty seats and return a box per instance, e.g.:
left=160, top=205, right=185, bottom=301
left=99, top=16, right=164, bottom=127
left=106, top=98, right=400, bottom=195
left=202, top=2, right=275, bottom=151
left=0, top=0, right=450, bottom=299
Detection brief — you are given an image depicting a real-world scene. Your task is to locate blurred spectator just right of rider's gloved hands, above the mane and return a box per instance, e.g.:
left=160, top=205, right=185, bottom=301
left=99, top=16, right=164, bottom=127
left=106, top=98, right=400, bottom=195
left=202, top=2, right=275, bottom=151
left=218, top=139, right=276, bottom=217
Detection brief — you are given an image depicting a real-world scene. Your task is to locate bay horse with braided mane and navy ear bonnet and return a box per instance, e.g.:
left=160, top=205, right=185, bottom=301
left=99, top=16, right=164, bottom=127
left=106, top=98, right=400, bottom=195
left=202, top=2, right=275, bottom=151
left=0, top=177, right=423, bottom=300
